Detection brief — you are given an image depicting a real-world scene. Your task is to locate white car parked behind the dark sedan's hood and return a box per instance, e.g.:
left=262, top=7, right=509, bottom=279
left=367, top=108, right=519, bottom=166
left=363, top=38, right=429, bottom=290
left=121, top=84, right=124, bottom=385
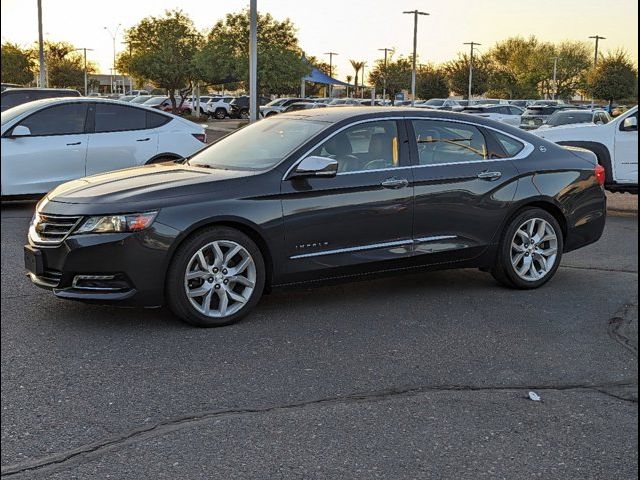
left=1, top=97, right=206, bottom=197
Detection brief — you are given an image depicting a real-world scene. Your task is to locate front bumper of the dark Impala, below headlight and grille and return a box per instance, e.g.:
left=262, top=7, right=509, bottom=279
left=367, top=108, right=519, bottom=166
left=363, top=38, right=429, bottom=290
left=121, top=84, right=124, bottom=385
left=25, top=222, right=179, bottom=307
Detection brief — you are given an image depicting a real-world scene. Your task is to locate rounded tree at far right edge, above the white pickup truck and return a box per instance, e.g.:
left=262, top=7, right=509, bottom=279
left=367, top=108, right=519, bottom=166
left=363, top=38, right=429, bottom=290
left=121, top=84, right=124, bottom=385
left=587, top=50, right=638, bottom=106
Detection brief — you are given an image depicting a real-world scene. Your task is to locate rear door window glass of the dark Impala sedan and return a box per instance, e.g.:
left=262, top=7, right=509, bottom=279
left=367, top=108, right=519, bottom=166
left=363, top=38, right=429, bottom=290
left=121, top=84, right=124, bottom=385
left=412, top=120, right=487, bottom=165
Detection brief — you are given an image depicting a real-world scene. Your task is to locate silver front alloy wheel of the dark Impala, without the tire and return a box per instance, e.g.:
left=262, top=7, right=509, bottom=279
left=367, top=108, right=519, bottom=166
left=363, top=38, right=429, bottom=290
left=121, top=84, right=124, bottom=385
left=184, top=240, right=256, bottom=318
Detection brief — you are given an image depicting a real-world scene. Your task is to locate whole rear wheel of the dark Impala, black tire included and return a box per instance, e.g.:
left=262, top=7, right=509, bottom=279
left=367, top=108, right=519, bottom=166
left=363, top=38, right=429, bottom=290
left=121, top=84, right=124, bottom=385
left=491, top=208, right=564, bottom=290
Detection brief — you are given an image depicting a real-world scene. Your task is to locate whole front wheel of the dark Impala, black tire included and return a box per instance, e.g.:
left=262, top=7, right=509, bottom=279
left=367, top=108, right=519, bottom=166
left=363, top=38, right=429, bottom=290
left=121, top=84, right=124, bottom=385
left=166, top=227, right=266, bottom=327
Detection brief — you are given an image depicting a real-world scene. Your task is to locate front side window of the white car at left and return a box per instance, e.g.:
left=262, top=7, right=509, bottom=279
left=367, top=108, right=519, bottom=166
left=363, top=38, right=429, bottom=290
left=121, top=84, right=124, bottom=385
left=20, top=103, right=87, bottom=136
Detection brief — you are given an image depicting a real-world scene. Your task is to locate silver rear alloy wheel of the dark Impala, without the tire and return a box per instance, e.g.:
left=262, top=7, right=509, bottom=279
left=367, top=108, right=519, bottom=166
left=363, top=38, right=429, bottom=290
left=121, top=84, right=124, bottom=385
left=511, top=218, right=558, bottom=282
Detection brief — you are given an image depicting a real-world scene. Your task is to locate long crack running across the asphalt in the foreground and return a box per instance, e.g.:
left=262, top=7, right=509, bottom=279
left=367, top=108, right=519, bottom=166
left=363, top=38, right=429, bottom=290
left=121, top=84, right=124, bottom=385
left=0, top=379, right=637, bottom=477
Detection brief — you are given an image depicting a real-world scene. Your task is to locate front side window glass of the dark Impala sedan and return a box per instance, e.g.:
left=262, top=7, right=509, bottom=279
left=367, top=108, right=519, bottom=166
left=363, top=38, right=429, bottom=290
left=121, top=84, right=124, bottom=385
left=311, top=120, right=400, bottom=172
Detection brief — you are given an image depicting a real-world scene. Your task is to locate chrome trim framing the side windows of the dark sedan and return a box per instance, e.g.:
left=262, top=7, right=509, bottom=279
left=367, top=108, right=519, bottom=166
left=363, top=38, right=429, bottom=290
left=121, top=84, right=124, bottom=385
left=282, top=116, right=535, bottom=181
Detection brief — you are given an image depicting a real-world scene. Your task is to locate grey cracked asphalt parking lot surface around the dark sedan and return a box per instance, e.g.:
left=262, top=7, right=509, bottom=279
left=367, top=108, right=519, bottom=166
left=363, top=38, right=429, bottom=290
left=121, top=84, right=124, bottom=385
left=2, top=196, right=638, bottom=479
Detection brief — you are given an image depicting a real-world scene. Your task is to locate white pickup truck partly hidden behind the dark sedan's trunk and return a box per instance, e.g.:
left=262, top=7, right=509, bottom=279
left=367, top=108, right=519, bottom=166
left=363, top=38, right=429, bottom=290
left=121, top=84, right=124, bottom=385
left=531, top=106, right=638, bottom=193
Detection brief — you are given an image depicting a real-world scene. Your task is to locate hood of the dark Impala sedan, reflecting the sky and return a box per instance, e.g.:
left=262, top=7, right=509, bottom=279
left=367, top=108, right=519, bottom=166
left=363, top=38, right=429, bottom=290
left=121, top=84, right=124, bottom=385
left=46, top=164, right=255, bottom=205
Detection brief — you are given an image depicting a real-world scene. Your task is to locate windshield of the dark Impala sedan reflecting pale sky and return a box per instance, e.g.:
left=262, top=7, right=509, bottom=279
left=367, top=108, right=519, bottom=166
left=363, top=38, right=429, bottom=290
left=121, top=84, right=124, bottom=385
left=188, top=115, right=329, bottom=170
